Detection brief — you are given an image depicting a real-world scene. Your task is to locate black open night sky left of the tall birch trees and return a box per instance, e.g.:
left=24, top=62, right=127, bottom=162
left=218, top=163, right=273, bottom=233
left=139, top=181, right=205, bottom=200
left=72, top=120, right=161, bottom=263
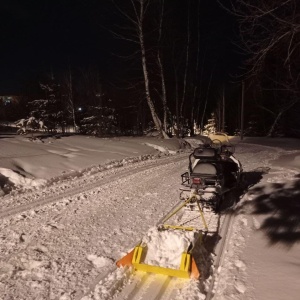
left=0, top=0, right=113, bottom=92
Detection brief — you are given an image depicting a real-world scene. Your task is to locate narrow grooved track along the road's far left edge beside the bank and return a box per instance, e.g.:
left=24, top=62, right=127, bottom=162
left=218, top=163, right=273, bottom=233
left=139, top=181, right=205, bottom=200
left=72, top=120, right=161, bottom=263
left=0, top=155, right=186, bottom=219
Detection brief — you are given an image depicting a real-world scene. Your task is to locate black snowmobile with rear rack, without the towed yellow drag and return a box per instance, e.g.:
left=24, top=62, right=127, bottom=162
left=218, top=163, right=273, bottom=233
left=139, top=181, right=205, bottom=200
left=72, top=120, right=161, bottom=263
left=180, top=140, right=242, bottom=212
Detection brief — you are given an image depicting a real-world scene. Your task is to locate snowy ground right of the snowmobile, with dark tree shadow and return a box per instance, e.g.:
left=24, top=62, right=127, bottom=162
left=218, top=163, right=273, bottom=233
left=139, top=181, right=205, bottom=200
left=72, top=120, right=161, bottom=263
left=214, top=138, right=300, bottom=300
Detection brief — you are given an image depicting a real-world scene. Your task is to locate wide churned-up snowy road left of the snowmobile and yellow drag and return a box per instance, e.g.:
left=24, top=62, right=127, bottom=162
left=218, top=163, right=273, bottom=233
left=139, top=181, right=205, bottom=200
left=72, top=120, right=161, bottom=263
left=0, top=157, right=195, bottom=299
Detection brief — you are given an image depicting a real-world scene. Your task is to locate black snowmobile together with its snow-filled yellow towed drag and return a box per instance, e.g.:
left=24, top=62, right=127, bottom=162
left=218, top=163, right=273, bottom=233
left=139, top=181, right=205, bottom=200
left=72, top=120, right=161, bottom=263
left=116, top=140, right=242, bottom=279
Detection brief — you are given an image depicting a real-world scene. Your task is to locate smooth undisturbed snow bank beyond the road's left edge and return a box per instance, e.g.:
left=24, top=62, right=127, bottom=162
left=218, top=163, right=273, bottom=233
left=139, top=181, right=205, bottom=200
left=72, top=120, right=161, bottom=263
left=0, top=135, right=182, bottom=195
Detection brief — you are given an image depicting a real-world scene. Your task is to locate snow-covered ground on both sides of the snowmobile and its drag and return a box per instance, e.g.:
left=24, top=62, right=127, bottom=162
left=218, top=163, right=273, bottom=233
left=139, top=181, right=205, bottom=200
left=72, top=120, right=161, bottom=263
left=0, top=134, right=300, bottom=300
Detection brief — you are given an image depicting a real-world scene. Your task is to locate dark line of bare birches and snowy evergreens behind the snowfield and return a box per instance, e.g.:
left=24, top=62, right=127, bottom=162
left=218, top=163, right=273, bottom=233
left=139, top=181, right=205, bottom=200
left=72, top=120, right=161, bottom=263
left=1, top=0, right=300, bottom=138
